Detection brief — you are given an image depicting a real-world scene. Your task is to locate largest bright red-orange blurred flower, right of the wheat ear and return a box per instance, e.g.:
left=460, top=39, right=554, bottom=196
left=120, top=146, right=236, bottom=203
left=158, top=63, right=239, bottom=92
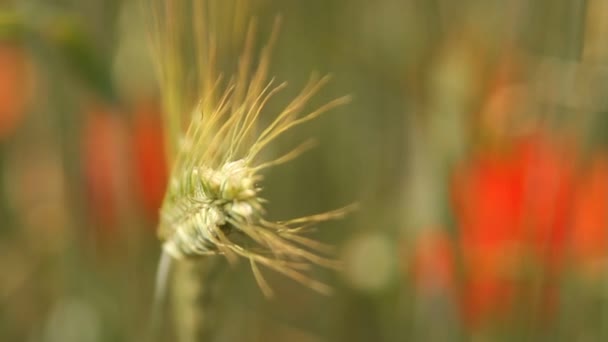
left=452, top=135, right=573, bottom=324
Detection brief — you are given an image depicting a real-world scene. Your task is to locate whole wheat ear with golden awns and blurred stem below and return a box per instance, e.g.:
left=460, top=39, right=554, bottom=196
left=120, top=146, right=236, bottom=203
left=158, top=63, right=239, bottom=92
left=146, top=0, right=352, bottom=341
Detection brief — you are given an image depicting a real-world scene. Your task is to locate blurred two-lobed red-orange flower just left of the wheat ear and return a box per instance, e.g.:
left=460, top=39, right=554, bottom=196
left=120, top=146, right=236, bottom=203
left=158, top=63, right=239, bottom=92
left=82, top=101, right=167, bottom=235
